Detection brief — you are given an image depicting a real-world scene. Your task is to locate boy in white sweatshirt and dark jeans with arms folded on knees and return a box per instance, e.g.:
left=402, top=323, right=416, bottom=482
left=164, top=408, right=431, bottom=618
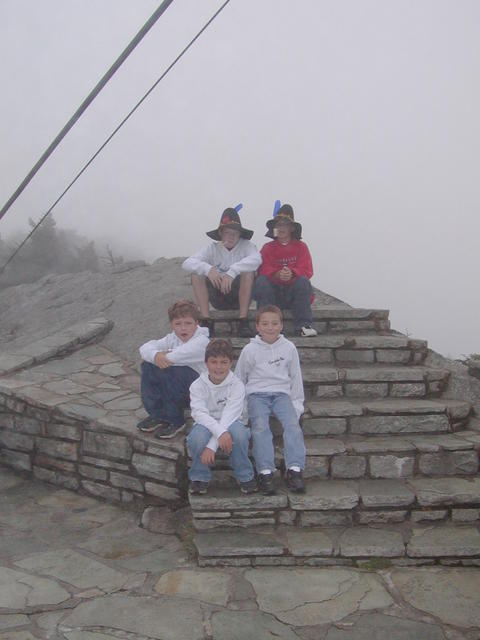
left=137, top=300, right=208, bottom=438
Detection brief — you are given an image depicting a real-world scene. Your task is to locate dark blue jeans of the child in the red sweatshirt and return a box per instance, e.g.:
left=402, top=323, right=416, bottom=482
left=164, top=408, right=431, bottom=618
left=252, top=276, right=313, bottom=329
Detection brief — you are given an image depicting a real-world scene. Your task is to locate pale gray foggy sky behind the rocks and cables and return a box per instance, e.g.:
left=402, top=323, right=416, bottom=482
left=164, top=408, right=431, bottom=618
left=0, top=0, right=480, bottom=357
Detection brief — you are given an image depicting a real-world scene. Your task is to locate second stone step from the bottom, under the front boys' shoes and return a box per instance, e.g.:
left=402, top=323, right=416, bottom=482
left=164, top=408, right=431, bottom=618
left=189, top=476, right=480, bottom=531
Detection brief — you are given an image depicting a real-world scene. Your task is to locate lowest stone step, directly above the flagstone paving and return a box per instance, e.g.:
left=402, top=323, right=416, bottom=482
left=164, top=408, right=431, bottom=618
left=194, top=523, right=480, bottom=568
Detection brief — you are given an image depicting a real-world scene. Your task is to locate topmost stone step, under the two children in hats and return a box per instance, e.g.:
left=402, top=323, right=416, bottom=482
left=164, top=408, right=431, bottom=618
left=210, top=305, right=390, bottom=335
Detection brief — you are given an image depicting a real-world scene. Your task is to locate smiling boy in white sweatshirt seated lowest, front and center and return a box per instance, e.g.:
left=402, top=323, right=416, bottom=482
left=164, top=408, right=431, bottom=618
left=187, top=339, right=257, bottom=494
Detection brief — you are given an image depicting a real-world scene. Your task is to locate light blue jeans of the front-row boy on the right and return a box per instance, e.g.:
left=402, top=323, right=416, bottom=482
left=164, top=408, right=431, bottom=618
left=247, top=393, right=305, bottom=473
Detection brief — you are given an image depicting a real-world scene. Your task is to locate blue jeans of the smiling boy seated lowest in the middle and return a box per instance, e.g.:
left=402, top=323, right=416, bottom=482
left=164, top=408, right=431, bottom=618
left=187, top=420, right=254, bottom=482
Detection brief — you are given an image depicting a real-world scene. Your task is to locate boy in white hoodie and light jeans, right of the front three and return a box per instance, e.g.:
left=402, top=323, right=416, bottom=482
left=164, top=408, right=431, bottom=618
left=235, top=305, right=305, bottom=495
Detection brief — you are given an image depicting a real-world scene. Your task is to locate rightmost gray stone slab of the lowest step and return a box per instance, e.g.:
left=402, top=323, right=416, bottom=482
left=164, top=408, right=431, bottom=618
left=407, top=525, right=480, bottom=558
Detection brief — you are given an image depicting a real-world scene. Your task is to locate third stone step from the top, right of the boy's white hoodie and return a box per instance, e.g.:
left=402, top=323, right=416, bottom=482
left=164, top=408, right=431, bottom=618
left=302, top=364, right=450, bottom=401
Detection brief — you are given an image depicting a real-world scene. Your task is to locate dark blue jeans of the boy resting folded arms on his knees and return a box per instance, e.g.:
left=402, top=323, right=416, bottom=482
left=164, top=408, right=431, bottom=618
left=141, top=362, right=198, bottom=427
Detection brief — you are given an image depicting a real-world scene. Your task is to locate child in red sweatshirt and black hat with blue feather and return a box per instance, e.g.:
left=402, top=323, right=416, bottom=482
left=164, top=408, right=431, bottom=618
left=253, top=200, right=317, bottom=338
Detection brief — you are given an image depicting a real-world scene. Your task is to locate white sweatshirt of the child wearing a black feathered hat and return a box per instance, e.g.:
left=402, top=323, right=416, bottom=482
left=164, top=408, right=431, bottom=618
left=182, top=238, right=262, bottom=278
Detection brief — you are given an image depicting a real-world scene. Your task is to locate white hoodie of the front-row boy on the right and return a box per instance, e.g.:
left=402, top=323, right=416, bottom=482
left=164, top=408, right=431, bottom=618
left=235, top=335, right=305, bottom=417
